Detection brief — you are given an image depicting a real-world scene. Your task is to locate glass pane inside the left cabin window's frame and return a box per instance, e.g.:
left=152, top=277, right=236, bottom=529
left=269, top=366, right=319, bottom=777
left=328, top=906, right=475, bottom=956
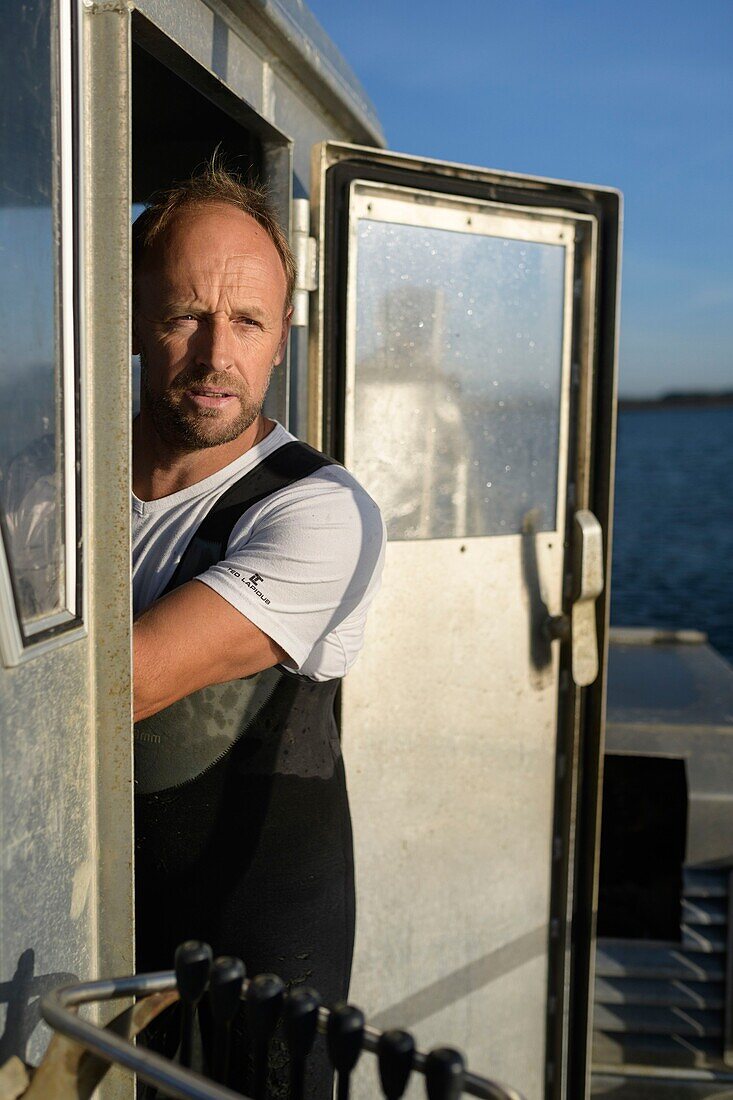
left=0, top=0, right=65, bottom=628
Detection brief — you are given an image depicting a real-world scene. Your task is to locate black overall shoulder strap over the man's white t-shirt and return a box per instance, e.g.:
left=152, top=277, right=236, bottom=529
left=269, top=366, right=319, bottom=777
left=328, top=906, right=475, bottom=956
left=161, top=440, right=339, bottom=595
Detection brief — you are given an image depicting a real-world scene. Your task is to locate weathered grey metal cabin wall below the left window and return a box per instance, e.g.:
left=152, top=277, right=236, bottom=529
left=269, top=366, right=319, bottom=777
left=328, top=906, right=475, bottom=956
left=0, top=641, right=97, bottom=1063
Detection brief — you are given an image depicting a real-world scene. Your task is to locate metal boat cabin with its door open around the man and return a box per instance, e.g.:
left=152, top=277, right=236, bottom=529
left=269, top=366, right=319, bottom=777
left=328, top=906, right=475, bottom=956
left=0, top=0, right=621, bottom=1100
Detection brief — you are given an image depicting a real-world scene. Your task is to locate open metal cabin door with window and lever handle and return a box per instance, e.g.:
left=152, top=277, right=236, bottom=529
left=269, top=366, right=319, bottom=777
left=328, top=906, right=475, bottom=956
left=311, top=144, right=619, bottom=1098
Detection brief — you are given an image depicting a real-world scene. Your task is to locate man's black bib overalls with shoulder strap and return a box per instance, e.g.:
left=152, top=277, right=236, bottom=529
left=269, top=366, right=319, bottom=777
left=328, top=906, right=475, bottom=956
left=135, top=442, right=354, bottom=1100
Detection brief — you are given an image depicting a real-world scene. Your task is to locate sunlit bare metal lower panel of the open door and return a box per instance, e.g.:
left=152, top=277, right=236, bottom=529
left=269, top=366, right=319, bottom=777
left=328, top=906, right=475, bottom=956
left=343, top=538, right=560, bottom=1097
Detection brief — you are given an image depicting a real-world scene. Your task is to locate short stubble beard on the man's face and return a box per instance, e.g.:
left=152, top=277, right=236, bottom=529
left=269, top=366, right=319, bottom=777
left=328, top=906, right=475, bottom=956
left=140, top=349, right=272, bottom=451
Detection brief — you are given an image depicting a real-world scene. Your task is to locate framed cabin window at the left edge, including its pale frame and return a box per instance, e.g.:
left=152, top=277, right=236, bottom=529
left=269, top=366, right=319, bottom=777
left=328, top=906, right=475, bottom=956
left=0, top=0, right=80, bottom=660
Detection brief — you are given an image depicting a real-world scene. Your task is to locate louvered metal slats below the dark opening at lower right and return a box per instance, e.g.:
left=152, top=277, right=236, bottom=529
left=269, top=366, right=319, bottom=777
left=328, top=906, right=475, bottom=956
left=593, top=867, right=730, bottom=1066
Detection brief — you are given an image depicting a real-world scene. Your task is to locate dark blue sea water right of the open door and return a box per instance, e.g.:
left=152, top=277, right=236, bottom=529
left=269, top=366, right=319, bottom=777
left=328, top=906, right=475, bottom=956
left=611, top=406, right=733, bottom=662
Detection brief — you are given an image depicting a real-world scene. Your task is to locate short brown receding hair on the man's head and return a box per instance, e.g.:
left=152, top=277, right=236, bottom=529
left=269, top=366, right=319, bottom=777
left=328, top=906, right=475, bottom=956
left=132, top=156, right=296, bottom=309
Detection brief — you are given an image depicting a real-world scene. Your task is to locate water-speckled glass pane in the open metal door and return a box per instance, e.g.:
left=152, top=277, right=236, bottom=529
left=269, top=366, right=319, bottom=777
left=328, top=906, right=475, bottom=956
left=351, top=219, right=565, bottom=539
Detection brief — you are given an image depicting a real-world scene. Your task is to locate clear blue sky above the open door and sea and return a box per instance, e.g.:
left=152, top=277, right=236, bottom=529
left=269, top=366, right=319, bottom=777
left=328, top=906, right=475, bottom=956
left=308, top=0, right=733, bottom=395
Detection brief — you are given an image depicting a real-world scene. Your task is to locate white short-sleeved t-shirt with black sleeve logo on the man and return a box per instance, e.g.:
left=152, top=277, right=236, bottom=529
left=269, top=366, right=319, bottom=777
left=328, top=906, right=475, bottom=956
left=132, top=425, right=385, bottom=680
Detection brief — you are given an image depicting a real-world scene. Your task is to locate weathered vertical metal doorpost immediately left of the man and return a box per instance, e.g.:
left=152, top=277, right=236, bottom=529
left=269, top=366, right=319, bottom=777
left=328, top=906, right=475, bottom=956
left=81, top=6, right=134, bottom=1097
